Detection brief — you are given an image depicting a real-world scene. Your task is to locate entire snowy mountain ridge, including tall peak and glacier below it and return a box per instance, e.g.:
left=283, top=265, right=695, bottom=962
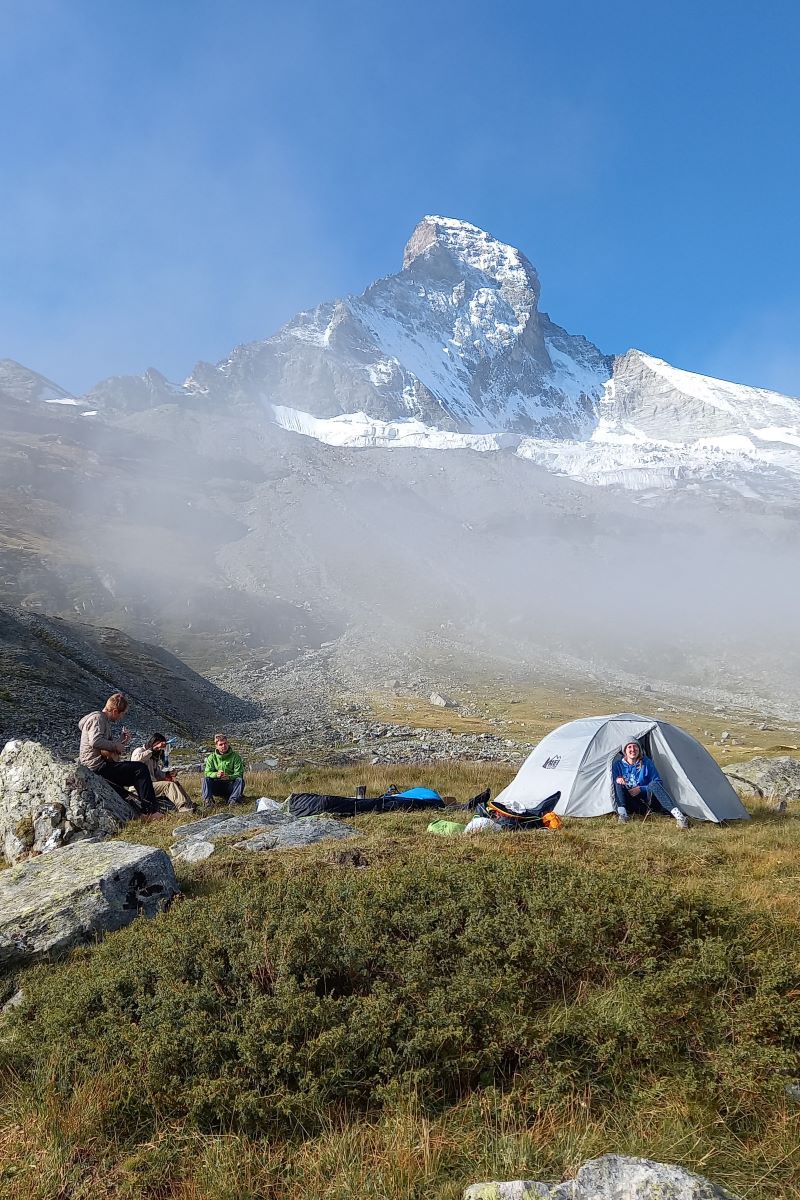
left=9, top=216, right=800, bottom=504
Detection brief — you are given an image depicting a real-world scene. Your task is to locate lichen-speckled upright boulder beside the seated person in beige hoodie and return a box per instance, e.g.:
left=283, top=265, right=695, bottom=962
left=0, top=740, right=138, bottom=863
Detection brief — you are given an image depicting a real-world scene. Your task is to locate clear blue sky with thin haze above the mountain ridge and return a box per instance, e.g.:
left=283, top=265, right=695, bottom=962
left=0, top=0, right=800, bottom=395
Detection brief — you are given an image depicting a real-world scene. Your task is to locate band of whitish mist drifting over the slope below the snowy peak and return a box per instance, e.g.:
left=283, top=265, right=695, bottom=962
left=10, top=388, right=800, bottom=704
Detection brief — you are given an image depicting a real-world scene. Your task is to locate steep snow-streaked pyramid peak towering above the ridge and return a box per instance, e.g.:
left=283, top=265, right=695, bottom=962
left=187, top=216, right=610, bottom=437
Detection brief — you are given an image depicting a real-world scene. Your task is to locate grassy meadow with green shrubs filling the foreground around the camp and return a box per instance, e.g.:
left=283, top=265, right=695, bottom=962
left=0, top=753, right=800, bottom=1200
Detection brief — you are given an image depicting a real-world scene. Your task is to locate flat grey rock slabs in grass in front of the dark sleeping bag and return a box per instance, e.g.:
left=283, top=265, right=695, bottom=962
left=170, top=802, right=357, bottom=863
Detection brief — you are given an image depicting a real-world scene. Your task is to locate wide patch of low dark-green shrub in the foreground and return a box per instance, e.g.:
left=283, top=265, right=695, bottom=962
left=0, top=850, right=800, bottom=1141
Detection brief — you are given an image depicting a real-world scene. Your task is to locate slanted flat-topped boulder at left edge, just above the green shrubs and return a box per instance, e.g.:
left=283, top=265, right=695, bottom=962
left=0, top=841, right=179, bottom=966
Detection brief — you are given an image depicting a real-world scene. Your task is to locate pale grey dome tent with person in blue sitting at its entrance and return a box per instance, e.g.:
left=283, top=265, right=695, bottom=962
left=495, top=713, right=748, bottom=823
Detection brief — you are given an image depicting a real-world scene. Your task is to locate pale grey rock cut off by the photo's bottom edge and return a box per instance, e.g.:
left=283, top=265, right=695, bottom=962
left=464, top=1154, right=736, bottom=1200
